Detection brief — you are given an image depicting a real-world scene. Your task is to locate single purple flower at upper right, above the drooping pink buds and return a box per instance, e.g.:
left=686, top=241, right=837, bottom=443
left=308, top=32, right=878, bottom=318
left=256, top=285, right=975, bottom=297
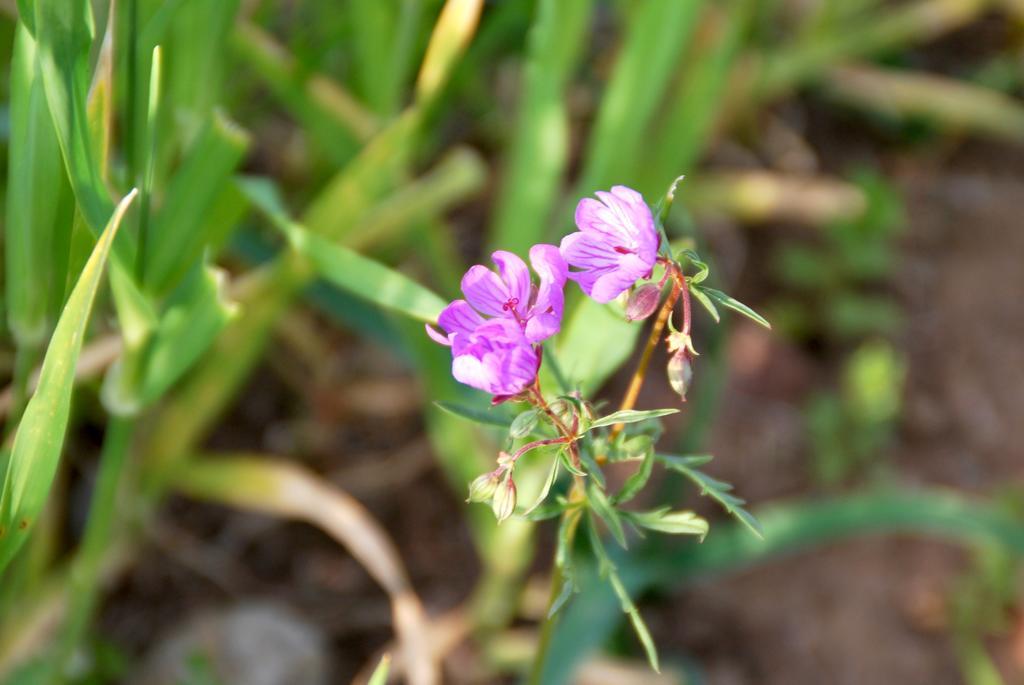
left=561, top=185, right=660, bottom=303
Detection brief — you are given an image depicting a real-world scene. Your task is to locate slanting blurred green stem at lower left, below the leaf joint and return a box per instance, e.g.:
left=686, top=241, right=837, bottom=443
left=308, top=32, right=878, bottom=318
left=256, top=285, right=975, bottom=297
left=51, top=417, right=134, bottom=675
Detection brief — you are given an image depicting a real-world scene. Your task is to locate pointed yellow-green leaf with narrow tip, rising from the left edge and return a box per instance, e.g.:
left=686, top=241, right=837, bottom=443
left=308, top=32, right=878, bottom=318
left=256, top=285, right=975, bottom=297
left=0, top=190, right=137, bottom=569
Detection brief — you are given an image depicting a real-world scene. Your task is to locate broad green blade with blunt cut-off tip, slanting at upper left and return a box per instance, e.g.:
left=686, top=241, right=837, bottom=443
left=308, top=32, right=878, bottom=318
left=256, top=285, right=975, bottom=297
left=144, top=111, right=249, bottom=294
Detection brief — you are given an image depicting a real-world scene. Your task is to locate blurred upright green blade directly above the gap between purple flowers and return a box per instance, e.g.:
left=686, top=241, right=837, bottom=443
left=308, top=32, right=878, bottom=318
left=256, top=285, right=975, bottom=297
left=490, top=0, right=592, bottom=254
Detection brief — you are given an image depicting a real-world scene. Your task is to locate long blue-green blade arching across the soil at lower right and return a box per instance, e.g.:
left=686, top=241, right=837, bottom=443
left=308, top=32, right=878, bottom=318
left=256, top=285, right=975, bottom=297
left=542, top=490, right=1024, bottom=683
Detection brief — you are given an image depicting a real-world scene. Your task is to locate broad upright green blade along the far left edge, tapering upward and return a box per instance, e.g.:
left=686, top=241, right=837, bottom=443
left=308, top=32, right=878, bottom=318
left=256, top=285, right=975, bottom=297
left=4, top=23, right=74, bottom=345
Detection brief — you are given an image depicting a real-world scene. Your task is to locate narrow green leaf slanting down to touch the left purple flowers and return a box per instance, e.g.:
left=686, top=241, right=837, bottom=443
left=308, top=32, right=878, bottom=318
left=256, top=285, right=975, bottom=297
left=244, top=182, right=447, bottom=323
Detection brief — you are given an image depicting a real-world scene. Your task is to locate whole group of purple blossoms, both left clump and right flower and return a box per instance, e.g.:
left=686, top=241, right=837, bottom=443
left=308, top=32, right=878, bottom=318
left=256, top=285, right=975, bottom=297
left=427, top=185, right=660, bottom=402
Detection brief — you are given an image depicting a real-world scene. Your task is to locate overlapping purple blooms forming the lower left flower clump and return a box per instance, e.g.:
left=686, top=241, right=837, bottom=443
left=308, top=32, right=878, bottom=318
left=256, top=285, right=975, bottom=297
left=427, top=245, right=568, bottom=396
